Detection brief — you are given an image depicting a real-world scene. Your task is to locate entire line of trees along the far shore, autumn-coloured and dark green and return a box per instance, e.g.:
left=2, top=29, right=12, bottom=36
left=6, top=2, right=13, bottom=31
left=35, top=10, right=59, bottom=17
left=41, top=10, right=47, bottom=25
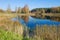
left=0, top=5, right=60, bottom=13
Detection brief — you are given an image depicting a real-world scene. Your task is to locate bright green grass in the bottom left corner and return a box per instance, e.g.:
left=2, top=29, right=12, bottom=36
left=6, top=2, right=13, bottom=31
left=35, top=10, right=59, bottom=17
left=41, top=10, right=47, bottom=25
left=0, top=30, right=23, bottom=40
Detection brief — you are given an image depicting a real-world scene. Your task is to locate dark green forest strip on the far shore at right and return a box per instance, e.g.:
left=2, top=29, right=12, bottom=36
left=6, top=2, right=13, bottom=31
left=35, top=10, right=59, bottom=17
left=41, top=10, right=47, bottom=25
left=31, top=7, right=60, bottom=13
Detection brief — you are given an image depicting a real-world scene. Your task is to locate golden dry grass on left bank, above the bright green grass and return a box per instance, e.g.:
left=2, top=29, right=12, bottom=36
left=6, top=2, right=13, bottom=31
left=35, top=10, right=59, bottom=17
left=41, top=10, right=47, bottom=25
left=0, top=17, right=23, bottom=34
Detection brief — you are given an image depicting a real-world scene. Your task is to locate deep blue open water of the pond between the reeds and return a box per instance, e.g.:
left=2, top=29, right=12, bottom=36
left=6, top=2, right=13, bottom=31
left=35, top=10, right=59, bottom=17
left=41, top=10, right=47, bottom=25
left=12, top=17, right=60, bottom=28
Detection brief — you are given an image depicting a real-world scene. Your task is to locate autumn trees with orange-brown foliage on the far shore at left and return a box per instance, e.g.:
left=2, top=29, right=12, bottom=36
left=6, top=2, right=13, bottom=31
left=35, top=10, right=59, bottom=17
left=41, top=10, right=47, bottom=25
left=0, top=5, right=29, bottom=13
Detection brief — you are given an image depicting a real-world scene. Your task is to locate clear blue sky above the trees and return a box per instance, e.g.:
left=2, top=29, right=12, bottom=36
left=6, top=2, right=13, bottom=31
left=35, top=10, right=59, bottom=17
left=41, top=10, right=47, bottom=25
left=0, top=0, right=60, bottom=10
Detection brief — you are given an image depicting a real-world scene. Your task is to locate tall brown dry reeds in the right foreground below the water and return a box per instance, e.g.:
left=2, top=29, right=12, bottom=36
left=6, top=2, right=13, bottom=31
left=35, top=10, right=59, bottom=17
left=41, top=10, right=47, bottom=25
left=32, top=25, right=60, bottom=40
